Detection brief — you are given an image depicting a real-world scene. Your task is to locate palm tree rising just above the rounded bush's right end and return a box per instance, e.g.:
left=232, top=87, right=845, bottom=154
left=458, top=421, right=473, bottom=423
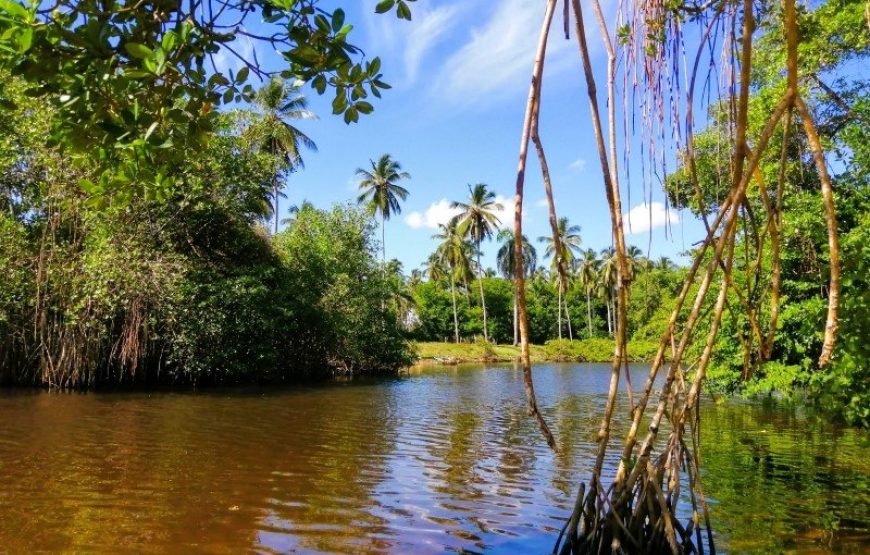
left=356, top=154, right=411, bottom=270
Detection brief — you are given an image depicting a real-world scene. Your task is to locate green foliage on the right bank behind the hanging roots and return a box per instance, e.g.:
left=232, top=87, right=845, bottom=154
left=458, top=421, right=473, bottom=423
left=664, top=0, right=870, bottom=426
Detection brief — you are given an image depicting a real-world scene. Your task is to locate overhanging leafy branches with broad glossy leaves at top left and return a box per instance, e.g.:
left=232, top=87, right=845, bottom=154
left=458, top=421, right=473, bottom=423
left=0, top=0, right=411, bottom=204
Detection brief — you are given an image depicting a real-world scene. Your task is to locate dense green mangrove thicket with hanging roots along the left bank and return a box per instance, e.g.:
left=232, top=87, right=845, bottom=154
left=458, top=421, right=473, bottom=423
left=0, top=79, right=410, bottom=387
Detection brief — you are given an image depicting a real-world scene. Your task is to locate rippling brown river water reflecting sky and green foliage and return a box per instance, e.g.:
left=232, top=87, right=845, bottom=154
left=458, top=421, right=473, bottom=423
left=0, top=364, right=870, bottom=554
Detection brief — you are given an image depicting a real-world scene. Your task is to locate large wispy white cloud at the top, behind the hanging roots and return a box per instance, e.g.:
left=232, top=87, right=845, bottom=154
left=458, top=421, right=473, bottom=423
left=435, top=0, right=576, bottom=103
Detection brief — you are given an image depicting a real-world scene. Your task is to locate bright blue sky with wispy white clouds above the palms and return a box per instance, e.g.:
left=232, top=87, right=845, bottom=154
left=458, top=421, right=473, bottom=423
left=224, top=0, right=703, bottom=272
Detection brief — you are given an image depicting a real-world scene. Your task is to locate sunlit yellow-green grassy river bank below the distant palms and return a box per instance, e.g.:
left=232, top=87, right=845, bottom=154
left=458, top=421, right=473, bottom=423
left=414, top=338, right=658, bottom=365
